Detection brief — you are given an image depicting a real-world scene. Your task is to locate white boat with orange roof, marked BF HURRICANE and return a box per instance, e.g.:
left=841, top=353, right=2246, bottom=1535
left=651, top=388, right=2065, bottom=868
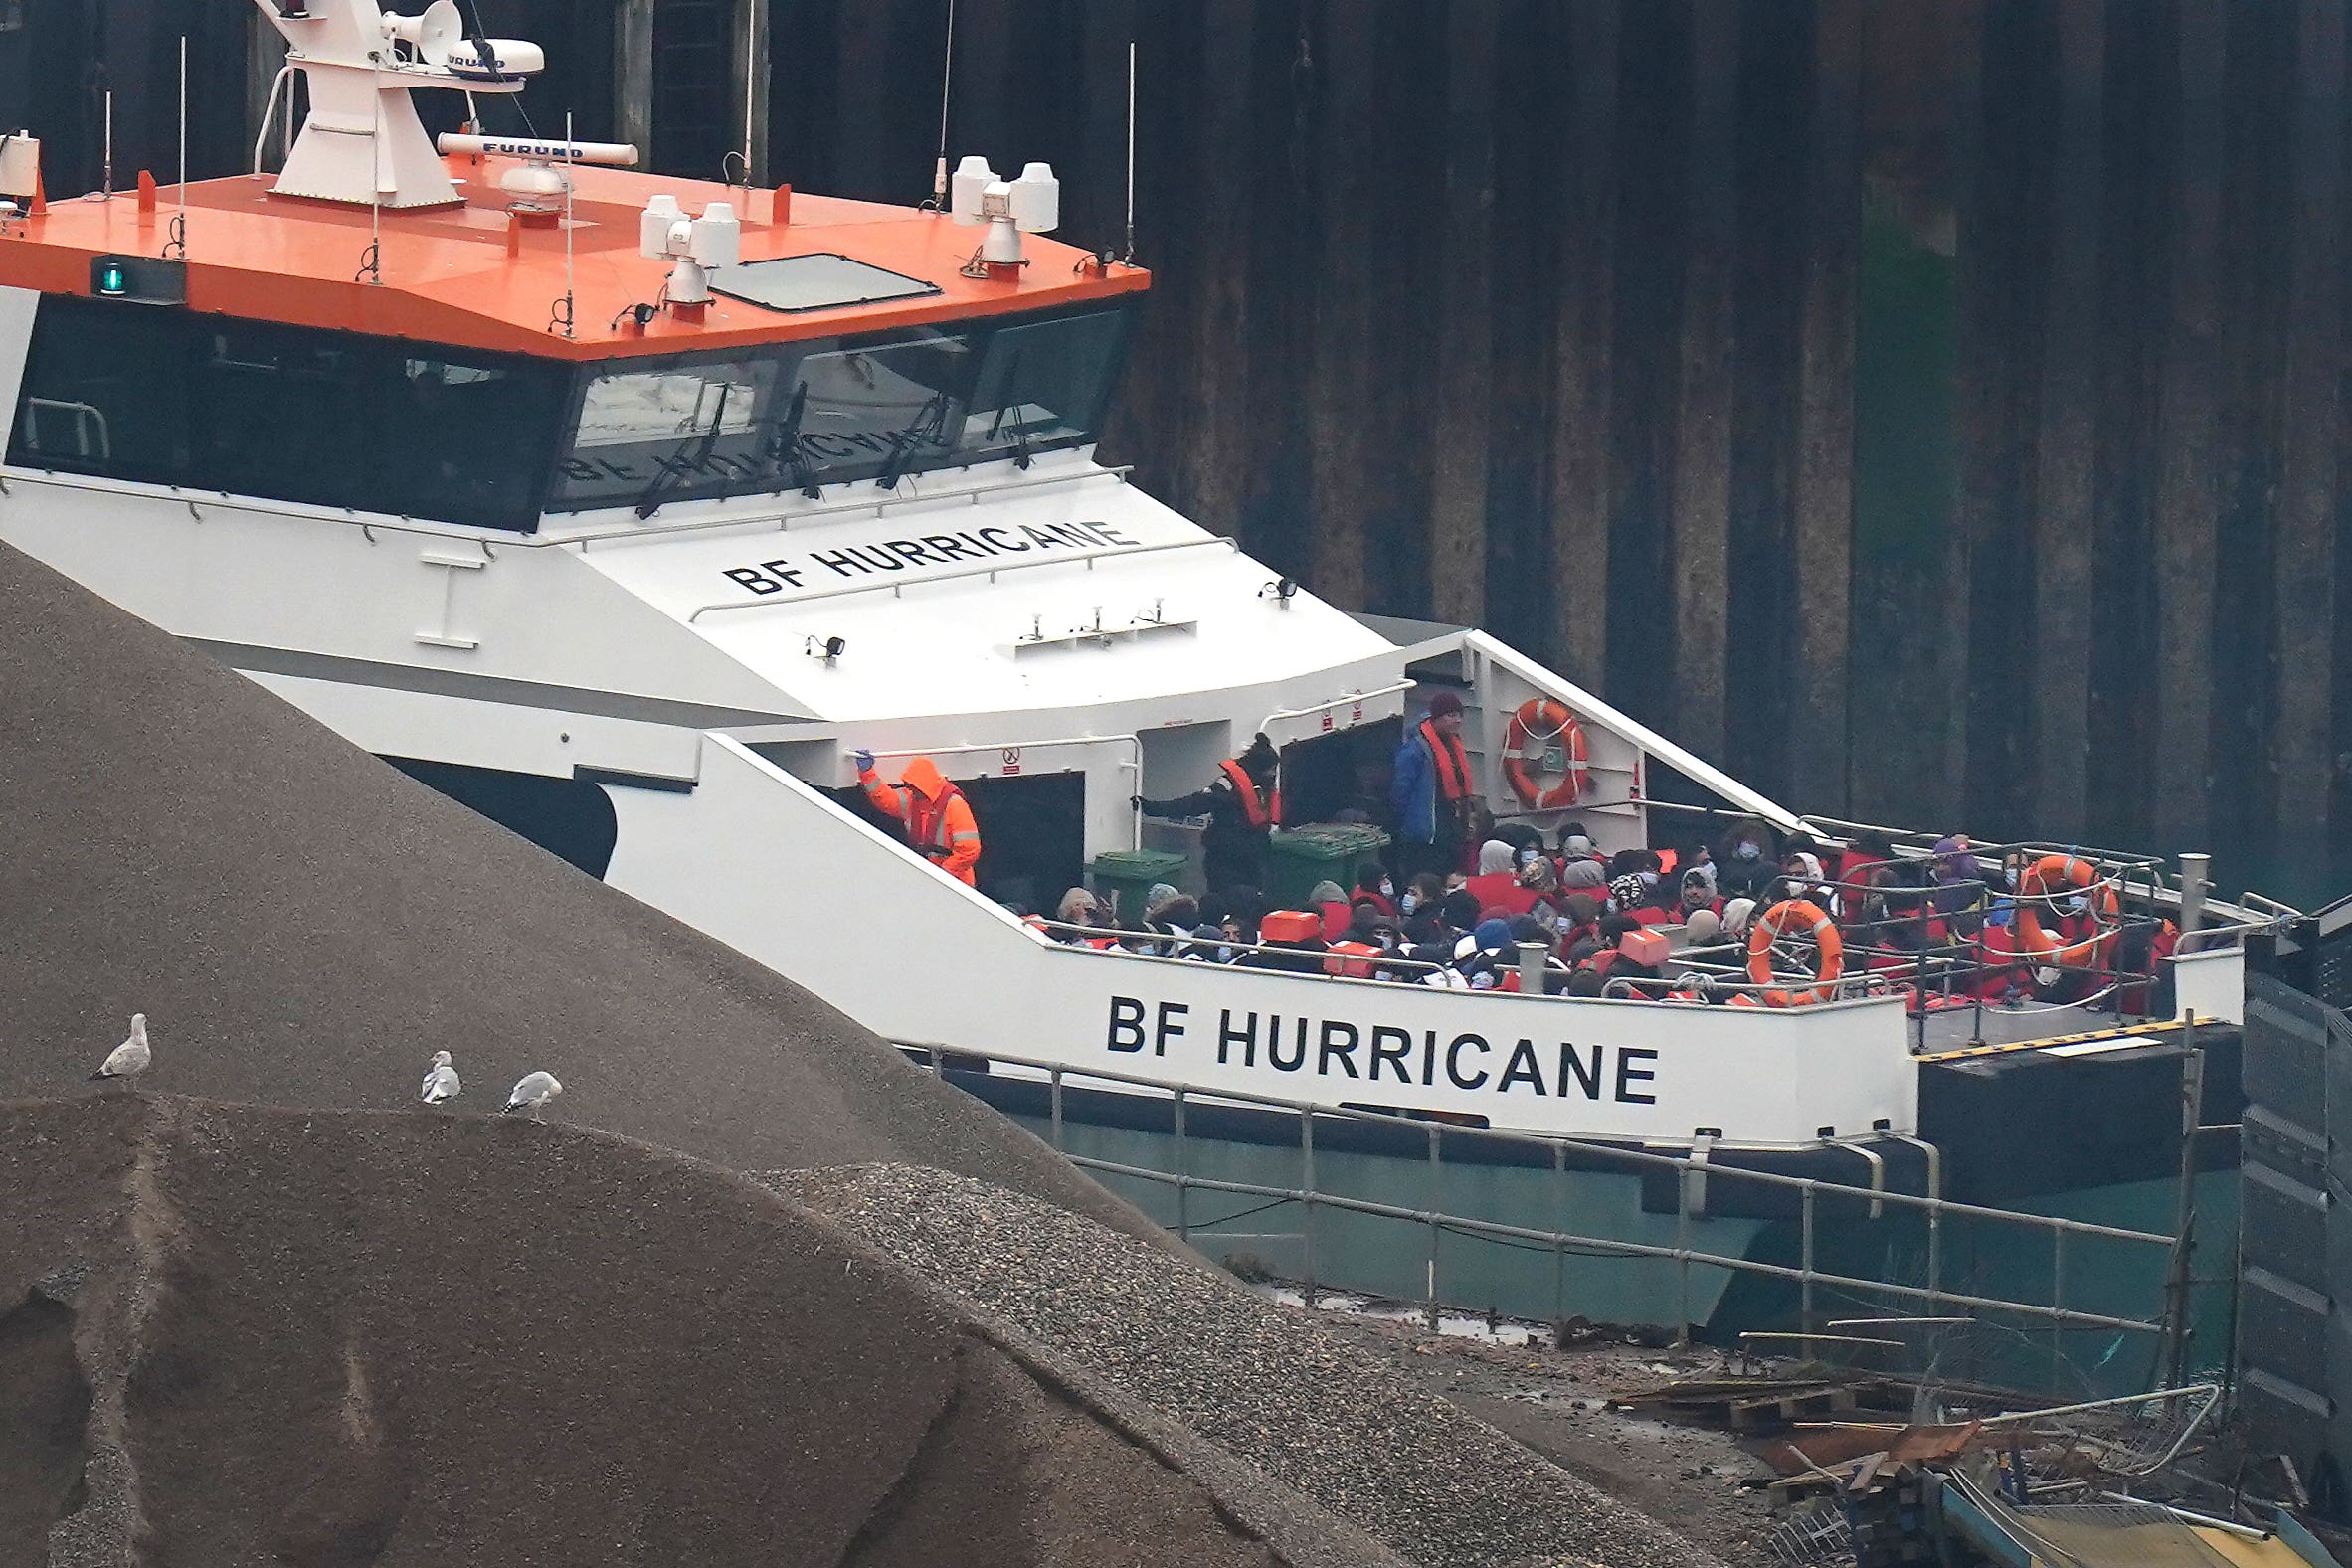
left=0, top=0, right=2293, bottom=1344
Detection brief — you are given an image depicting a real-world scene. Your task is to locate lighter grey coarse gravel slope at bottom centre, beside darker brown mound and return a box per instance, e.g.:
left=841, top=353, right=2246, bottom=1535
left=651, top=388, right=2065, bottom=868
left=760, top=1166, right=1717, bottom=1568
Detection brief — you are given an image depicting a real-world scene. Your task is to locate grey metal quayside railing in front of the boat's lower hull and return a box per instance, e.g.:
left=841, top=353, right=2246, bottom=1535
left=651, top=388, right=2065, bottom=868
left=903, top=1041, right=2185, bottom=1344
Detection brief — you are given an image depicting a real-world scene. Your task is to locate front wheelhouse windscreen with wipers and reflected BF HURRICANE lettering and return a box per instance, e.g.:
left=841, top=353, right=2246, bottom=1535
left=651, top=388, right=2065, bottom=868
left=548, top=305, right=1132, bottom=515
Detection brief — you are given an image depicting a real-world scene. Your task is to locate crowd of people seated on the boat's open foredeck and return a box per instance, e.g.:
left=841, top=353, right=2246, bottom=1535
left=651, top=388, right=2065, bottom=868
left=1037, top=818, right=2171, bottom=1011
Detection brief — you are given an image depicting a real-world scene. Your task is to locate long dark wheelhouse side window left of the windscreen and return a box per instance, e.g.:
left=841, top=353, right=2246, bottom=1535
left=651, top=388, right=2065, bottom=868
left=7, top=298, right=572, bottom=531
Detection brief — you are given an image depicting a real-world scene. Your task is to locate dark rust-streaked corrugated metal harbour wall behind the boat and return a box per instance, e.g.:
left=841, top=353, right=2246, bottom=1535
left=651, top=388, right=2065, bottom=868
left=0, top=0, right=2352, bottom=891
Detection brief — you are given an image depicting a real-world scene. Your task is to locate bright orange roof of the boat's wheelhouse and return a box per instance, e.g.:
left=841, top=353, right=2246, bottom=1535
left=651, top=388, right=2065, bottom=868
left=0, top=155, right=1150, bottom=360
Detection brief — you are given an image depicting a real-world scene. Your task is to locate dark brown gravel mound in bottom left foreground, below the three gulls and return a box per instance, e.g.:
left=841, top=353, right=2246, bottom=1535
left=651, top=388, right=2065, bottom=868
left=0, top=1091, right=1387, bottom=1568
